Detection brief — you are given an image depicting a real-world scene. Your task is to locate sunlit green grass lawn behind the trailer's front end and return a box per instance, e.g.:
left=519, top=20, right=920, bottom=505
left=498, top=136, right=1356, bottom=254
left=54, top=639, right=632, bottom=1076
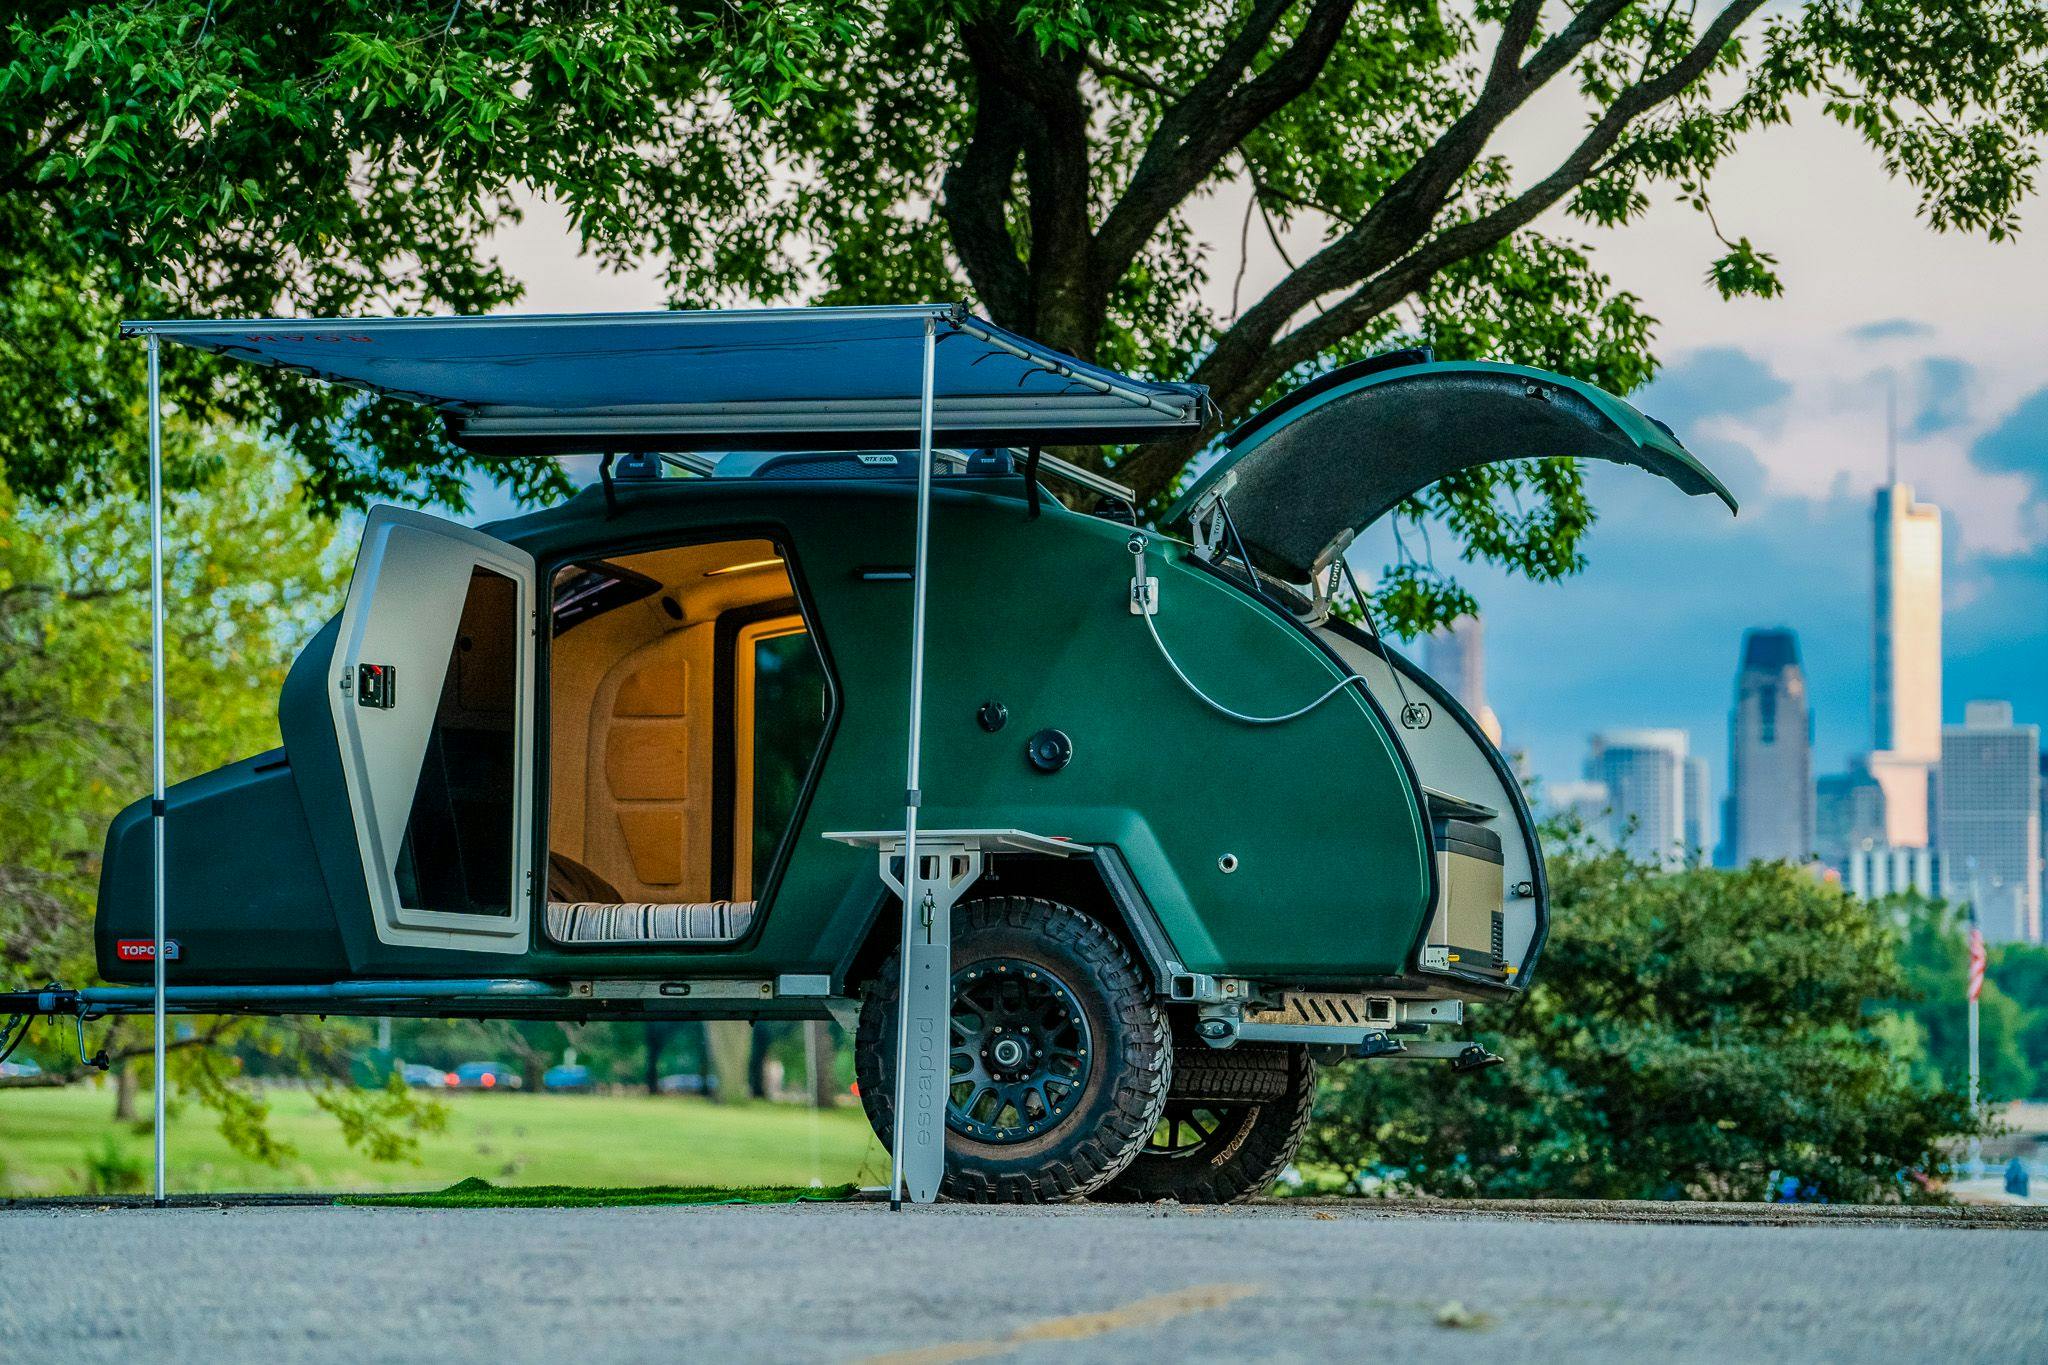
left=0, top=1085, right=889, bottom=1195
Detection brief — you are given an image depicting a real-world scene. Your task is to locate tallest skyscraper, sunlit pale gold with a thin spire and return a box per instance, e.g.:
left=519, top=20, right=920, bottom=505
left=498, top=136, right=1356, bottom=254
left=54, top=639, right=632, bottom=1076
left=1870, top=479, right=1942, bottom=847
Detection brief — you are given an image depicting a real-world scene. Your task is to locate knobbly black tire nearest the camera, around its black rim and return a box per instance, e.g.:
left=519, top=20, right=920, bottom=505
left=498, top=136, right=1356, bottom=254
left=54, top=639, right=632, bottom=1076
left=854, top=896, right=1174, bottom=1203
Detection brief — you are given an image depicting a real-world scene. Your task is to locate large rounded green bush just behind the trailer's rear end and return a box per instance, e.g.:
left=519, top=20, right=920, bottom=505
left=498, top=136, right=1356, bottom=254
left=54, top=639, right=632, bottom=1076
left=1303, top=849, right=1972, bottom=1201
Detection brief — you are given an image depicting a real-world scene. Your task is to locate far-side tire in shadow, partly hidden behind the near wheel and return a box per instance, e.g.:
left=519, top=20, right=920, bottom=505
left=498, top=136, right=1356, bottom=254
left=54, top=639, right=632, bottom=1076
left=1092, top=1038, right=1315, bottom=1203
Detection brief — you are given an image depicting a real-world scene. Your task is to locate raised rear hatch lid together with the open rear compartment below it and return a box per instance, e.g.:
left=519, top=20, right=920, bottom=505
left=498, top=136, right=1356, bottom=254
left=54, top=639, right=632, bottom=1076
left=1167, top=350, right=1735, bottom=988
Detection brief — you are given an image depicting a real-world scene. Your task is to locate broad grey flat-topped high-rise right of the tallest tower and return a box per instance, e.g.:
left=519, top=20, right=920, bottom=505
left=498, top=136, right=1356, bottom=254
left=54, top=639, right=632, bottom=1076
left=1939, top=702, right=2042, bottom=943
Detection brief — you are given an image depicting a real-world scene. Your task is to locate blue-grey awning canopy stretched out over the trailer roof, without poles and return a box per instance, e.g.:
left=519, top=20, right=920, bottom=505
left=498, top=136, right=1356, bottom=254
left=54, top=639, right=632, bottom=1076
left=121, top=305, right=1206, bottom=454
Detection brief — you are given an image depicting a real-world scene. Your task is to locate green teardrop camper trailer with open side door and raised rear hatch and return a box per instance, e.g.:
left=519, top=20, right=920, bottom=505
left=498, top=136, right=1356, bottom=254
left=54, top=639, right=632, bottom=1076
left=8, top=311, right=1733, bottom=1201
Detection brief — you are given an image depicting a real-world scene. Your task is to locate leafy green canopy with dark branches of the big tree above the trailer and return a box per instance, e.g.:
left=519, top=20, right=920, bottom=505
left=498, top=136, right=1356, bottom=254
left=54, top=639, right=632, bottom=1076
left=12, top=0, right=2048, bottom=626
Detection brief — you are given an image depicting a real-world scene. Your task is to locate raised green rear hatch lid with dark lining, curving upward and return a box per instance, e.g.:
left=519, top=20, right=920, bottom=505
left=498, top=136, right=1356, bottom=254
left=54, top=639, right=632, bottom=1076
left=1169, top=350, right=1735, bottom=583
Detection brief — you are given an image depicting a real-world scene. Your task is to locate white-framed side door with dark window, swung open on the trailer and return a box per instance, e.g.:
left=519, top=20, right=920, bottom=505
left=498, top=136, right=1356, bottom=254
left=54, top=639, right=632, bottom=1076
left=328, top=508, right=537, bottom=954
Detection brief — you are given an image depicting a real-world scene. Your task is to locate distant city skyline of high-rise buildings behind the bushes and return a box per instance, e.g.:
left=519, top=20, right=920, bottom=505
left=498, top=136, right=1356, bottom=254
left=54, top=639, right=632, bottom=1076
left=1507, top=450, right=2048, bottom=943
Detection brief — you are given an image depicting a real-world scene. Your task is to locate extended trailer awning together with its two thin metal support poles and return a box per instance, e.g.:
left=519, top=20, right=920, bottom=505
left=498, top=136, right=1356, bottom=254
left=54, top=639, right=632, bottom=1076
left=121, top=303, right=1206, bottom=1205
